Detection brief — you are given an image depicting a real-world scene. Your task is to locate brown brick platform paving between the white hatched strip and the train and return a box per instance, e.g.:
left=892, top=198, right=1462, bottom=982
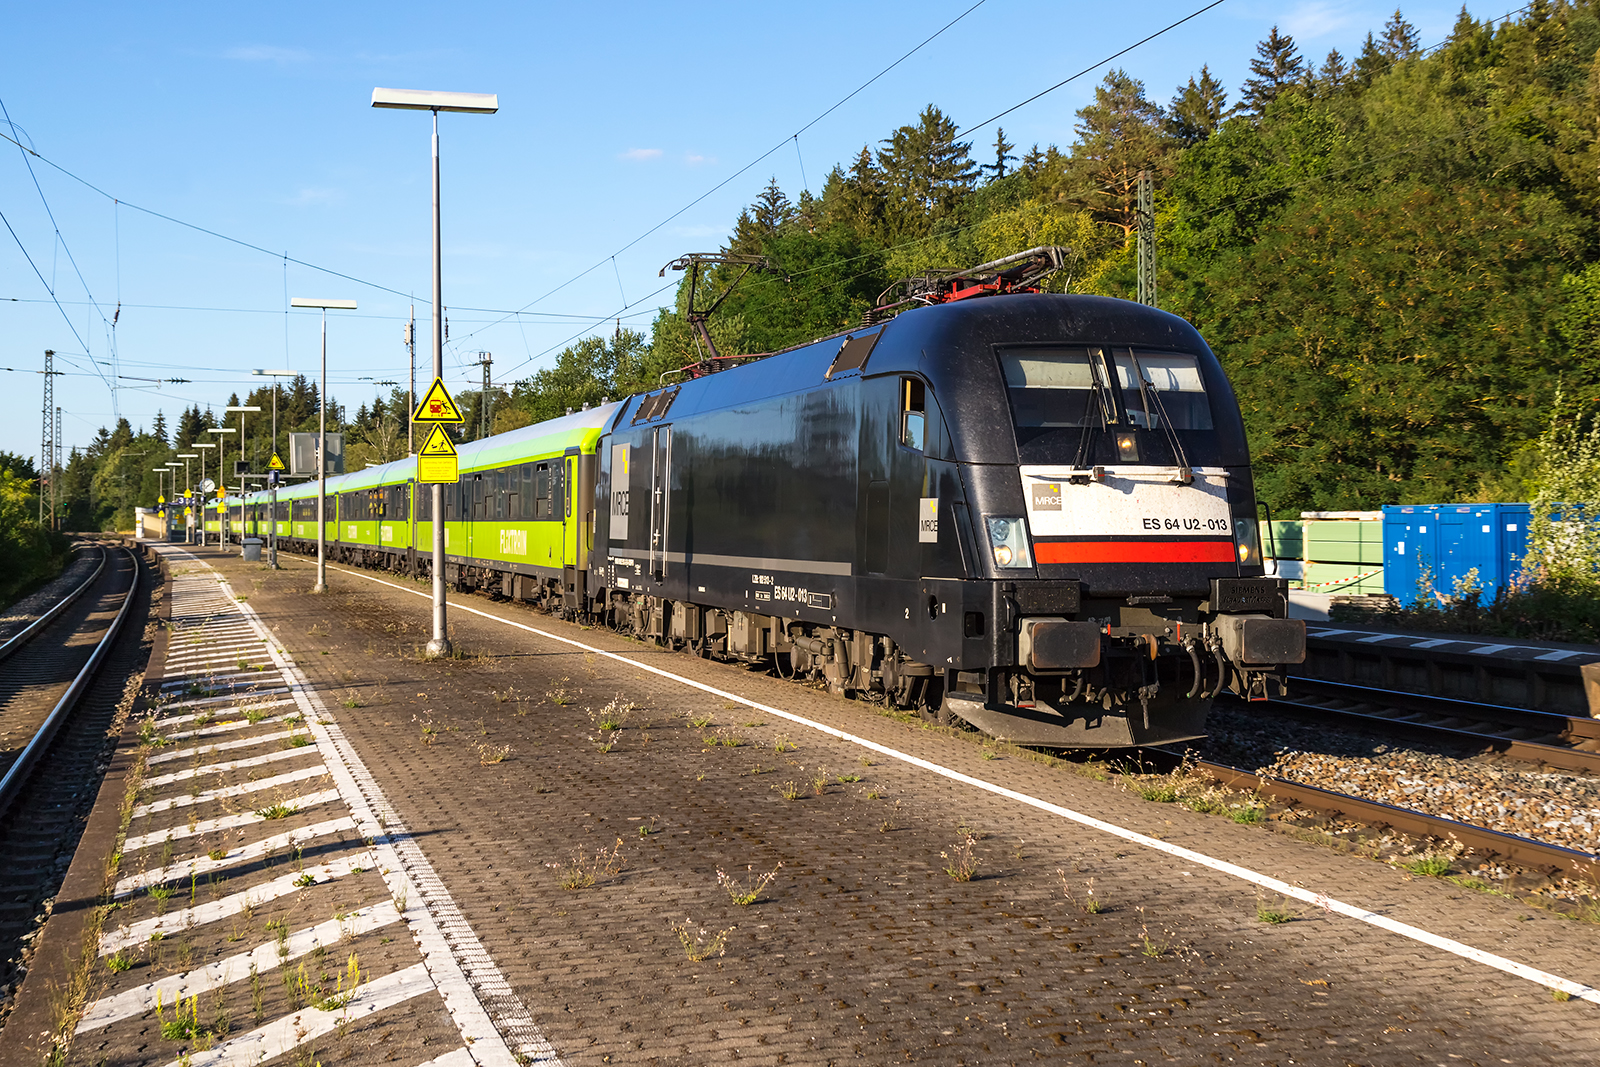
left=56, top=552, right=1600, bottom=1064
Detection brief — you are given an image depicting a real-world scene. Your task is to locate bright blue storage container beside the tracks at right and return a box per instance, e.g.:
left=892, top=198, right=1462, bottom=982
left=1384, top=504, right=1530, bottom=605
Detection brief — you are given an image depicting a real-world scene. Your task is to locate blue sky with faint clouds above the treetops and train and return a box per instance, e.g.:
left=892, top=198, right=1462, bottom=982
left=0, top=0, right=1484, bottom=454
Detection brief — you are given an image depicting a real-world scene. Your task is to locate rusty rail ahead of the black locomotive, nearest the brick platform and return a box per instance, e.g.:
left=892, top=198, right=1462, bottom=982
left=1190, top=753, right=1600, bottom=883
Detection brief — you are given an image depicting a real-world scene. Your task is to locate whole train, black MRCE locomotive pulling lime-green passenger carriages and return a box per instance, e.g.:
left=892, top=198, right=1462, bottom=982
left=235, top=294, right=1306, bottom=749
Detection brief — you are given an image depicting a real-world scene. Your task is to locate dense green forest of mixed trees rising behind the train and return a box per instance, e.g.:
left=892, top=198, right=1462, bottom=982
left=12, top=0, right=1600, bottom=530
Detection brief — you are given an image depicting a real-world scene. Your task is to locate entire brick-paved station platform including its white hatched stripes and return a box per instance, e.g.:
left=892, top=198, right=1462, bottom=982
left=18, top=545, right=1600, bottom=1067
